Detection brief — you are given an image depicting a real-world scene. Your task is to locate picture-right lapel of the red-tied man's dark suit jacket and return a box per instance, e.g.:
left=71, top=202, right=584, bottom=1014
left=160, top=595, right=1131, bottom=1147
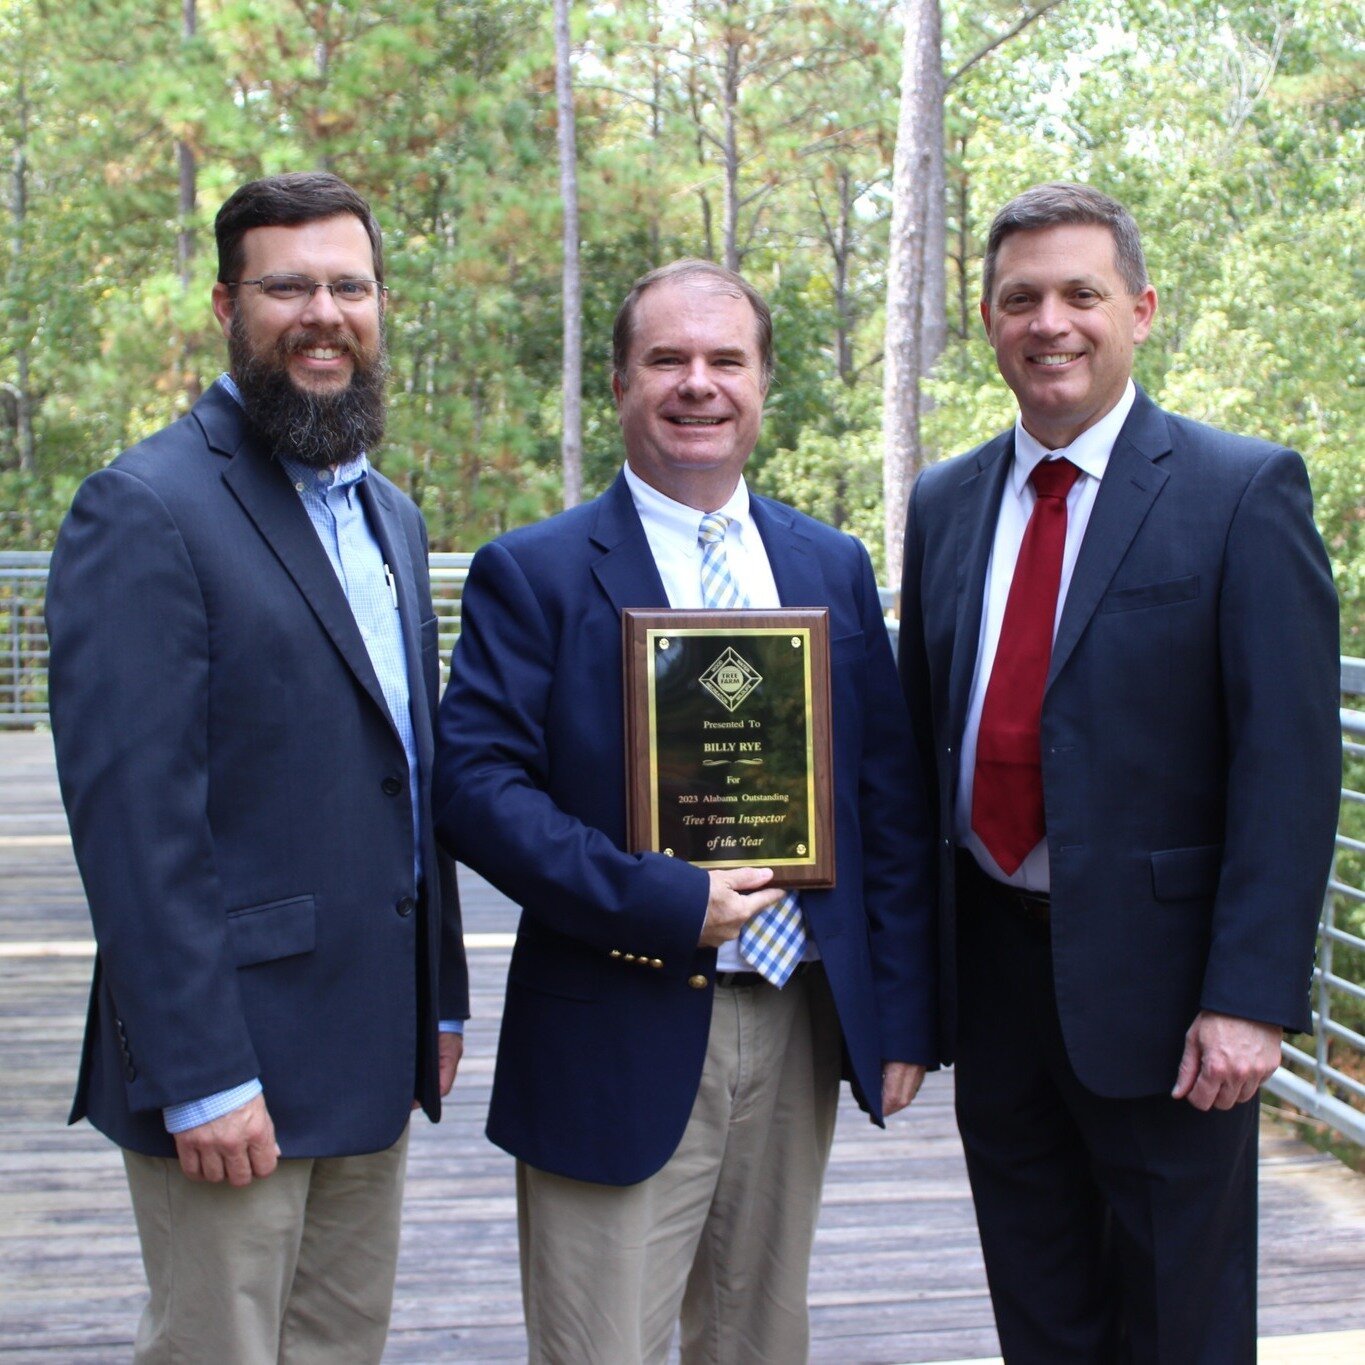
left=1047, top=389, right=1171, bottom=687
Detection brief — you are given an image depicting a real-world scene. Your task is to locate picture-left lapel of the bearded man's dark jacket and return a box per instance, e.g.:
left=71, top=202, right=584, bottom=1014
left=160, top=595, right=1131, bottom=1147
left=210, top=385, right=405, bottom=723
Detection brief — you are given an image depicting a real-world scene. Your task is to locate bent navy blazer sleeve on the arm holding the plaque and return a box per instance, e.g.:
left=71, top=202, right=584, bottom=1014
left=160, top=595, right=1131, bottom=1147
left=434, top=542, right=710, bottom=975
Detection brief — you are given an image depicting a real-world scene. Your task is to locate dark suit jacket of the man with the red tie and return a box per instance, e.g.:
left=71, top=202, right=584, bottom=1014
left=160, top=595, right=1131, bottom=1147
left=901, top=390, right=1340, bottom=1096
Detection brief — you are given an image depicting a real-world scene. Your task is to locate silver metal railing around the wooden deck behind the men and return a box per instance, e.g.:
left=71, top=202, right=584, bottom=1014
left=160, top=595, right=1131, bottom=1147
left=8, top=550, right=1365, bottom=1145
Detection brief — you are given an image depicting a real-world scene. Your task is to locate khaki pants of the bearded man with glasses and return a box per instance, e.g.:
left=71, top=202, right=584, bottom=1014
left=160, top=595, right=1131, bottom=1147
left=123, top=1129, right=408, bottom=1365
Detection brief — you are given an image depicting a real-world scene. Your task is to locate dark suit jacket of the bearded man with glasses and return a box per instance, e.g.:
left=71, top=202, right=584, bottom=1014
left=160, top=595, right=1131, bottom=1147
left=46, top=385, right=467, bottom=1156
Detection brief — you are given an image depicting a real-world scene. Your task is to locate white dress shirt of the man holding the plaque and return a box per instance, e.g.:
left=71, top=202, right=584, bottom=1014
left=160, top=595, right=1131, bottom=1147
left=625, top=465, right=820, bottom=972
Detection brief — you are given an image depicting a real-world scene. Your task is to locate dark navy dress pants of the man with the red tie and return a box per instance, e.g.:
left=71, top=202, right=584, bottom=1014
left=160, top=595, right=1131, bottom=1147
left=957, top=874, right=1259, bottom=1365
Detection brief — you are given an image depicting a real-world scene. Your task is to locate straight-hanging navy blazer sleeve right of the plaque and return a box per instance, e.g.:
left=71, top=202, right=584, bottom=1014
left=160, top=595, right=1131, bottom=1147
left=857, top=545, right=938, bottom=1066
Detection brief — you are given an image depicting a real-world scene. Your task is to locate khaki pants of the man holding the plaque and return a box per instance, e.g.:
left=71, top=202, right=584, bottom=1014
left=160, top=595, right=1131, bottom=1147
left=517, top=965, right=839, bottom=1365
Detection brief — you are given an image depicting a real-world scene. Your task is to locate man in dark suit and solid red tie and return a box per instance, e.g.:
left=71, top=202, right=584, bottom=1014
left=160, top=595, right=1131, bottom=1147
left=901, top=184, right=1340, bottom=1365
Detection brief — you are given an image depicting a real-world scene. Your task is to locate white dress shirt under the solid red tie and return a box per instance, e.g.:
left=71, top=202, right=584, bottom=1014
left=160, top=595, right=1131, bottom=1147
left=954, top=379, right=1137, bottom=891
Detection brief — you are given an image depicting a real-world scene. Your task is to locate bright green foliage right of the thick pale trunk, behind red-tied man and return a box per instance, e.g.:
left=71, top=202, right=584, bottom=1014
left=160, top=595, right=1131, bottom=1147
left=927, top=0, right=1365, bottom=638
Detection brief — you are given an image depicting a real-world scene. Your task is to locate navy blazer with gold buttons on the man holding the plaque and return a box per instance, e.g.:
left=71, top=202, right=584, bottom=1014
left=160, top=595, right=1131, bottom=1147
left=435, top=476, right=934, bottom=1185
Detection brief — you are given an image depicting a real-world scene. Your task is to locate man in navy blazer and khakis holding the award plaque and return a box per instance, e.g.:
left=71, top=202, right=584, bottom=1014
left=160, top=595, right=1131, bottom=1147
left=435, top=261, right=935, bottom=1365
